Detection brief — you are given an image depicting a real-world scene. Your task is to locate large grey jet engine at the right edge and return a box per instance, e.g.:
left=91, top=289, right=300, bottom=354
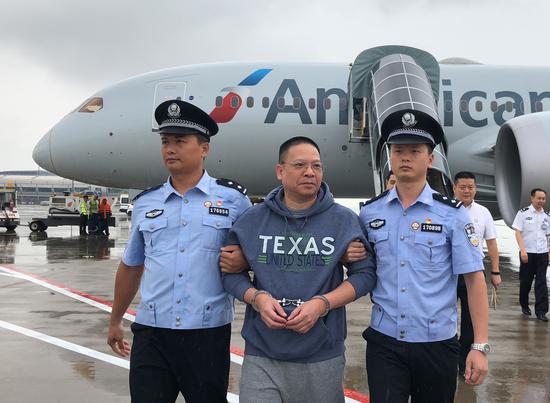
left=495, top=112, right=550, bottom=225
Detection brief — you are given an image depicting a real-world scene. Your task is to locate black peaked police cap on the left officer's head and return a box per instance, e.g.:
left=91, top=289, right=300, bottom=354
left=155, top=99, right=218, bottom=140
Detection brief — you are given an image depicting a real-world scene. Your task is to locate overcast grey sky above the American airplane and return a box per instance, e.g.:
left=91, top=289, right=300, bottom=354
left=0, top=0, right=550, bottom=171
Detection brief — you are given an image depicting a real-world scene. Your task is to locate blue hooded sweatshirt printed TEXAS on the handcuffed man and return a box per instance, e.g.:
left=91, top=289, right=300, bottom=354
left=223, top=183, right=376, bottom=363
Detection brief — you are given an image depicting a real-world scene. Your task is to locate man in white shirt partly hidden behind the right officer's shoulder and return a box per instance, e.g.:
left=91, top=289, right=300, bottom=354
left=453, top=171, right=502, bottom=376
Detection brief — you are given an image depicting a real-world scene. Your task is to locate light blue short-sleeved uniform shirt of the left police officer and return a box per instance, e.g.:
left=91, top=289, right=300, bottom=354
left=122, top=171, right=251, bottom=329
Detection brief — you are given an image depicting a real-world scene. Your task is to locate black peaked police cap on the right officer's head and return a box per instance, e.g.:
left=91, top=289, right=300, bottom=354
left=382, top=110, right=443, bottom=148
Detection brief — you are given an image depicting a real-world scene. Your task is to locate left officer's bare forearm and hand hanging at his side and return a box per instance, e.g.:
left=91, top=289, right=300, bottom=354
left=107, top=261, right=143, bottom=357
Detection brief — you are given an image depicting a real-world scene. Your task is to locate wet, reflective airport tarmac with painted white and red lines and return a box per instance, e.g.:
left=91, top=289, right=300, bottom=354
left=0, top=206, right=550, bottom=403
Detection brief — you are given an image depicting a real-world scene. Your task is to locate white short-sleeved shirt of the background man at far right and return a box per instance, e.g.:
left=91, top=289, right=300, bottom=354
left=512, top=204, right=550, bottom=253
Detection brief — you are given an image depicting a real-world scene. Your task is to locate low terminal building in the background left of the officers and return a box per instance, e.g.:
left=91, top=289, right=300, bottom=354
left=0, top=169, right=127, bottom=204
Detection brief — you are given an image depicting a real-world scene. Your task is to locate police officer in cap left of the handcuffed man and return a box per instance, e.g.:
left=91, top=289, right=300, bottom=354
left=107, top=100, right=251, bottom=403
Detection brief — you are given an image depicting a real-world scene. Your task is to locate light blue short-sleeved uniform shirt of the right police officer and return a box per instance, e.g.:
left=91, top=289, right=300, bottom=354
left=359, top=184, right=483, bottom=342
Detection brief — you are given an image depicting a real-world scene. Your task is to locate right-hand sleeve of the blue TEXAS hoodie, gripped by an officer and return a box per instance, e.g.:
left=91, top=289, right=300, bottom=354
left=344, top=213, right=376, bottom=299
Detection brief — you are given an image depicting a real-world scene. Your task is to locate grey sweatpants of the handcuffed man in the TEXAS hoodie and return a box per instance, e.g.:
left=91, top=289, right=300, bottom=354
left=239, top=355, right=346, bottom=403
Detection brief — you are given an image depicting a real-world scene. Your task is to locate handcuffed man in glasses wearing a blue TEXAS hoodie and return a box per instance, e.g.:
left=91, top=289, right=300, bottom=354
left=220, top=137, right=376, bottom=403
